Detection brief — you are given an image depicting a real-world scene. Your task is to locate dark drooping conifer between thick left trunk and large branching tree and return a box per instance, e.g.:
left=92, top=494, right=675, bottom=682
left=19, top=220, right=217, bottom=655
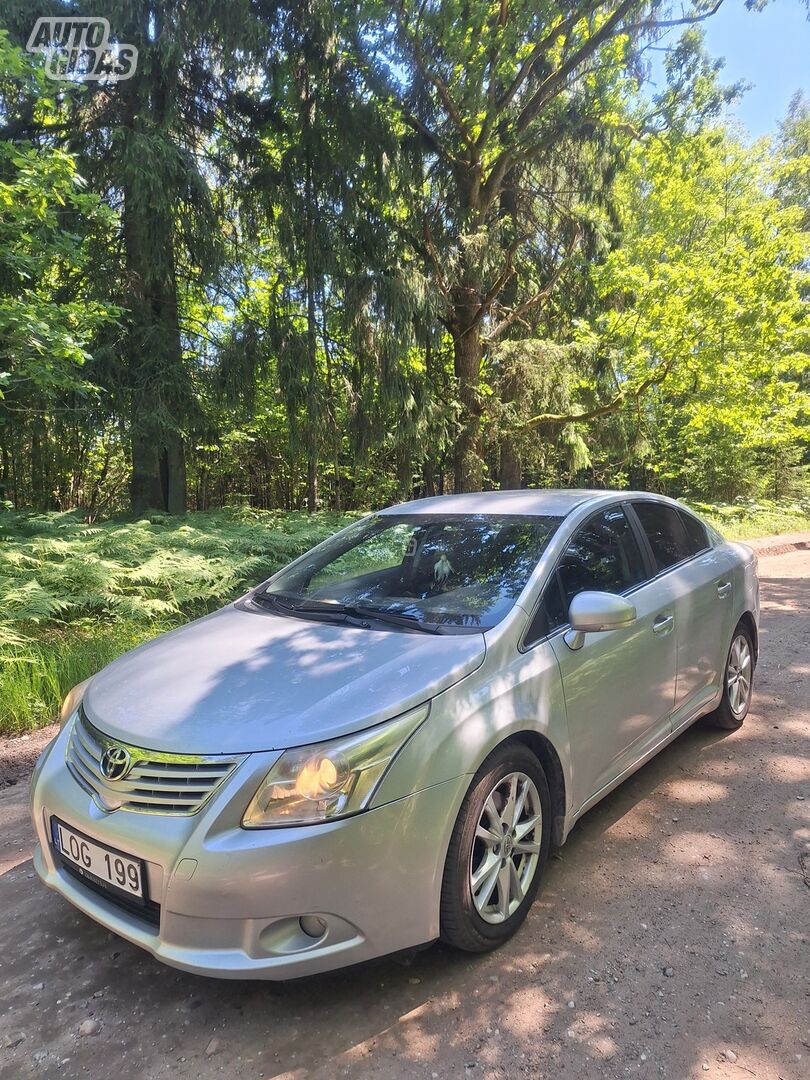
left=216, top=0, right=433, bottom=511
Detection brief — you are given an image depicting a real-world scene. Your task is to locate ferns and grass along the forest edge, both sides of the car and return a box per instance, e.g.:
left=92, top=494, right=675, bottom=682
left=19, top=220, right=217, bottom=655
left=0, top=494, right=810, bottom=734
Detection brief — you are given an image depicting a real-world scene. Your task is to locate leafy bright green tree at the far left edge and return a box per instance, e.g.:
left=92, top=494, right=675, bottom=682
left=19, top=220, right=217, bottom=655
left=0, top=38, right=119, bottom=508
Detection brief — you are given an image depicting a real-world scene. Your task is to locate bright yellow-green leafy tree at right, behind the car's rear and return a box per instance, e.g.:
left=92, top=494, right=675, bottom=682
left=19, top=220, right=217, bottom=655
left=582, top=130, right=810, bottom=499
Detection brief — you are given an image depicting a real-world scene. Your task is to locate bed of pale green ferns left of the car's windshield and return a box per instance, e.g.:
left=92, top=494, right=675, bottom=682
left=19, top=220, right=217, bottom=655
left=0, top=510, right=356, bottom=642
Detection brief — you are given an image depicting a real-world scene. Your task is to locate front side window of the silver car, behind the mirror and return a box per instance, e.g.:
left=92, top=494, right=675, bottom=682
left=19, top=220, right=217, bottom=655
left=526, top=507, right=647, bottom=644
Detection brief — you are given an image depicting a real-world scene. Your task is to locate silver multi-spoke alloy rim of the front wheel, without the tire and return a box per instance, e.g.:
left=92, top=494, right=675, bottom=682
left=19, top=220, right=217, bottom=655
left=470, top=772, right=543, bottom=923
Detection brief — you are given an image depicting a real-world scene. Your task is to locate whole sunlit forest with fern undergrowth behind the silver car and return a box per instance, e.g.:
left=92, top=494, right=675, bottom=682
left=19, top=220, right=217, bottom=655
left=0, top=0, right=810, bottom=725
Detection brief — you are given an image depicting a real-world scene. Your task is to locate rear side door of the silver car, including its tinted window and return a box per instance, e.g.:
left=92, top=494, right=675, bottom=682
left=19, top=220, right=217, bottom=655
left=631, top=500, right=733, bottom=730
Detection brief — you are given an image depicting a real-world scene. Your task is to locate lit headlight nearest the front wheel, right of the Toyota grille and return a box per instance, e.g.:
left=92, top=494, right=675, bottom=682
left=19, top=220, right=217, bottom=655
left=242, top=705, right=430, bottom=828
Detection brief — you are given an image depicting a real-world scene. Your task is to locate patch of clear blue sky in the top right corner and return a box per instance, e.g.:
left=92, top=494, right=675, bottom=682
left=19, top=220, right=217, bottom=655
left=652, top=0, right=810, bottom=138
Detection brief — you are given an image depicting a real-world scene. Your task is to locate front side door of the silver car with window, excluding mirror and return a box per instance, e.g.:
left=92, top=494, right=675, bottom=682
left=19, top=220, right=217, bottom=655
left=534, top=504, right=676, bottom=809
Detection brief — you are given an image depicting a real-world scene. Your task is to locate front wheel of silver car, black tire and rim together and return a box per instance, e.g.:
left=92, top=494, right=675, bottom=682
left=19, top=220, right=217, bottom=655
left=440, top=742, right=551, bottom=953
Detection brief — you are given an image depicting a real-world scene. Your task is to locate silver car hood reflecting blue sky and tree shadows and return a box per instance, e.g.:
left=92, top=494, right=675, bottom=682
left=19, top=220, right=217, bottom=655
left=83, top=604, right=486, bottom=754
